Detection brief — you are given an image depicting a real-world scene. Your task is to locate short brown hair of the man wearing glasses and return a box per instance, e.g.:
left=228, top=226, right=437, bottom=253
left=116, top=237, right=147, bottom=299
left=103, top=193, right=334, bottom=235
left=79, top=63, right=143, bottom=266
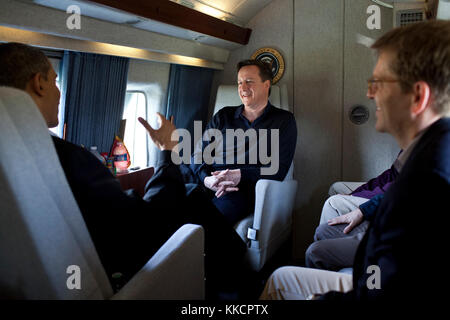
left=372, top=20, right=450, bottom=115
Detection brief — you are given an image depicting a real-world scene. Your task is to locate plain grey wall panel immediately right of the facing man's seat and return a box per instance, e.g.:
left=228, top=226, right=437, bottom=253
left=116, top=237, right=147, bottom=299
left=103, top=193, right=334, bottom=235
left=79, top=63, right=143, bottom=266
left=293, top=0, right=344, bottom=260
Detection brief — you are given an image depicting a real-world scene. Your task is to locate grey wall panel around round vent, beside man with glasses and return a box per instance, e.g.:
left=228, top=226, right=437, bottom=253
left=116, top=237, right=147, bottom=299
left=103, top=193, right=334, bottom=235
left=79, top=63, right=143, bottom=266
left=342, top=0, right=399, bottom=181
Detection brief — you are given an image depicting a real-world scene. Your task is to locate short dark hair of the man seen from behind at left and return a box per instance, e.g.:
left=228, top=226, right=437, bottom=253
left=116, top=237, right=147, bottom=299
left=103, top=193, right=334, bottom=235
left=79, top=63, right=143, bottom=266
left=0, top=42, right=50, bottom=90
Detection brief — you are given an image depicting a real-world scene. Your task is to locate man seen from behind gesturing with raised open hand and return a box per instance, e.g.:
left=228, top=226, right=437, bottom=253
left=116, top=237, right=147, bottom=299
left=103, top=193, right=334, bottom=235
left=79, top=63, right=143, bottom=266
left=0, top=43, right=246, bottom=294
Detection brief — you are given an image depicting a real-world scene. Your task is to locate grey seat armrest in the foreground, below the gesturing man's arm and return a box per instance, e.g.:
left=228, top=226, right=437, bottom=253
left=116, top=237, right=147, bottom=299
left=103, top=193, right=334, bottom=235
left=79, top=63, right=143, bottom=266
left=113, top=224, right=205, bottom=300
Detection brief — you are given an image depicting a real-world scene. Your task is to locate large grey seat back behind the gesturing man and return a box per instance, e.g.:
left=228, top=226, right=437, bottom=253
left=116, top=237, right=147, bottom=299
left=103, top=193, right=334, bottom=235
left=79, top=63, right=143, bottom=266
left=0, top=87, right=112, bottom=299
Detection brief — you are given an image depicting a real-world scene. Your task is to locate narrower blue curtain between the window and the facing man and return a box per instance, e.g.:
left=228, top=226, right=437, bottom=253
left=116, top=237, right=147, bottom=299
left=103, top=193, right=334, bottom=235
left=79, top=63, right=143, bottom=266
left=166, top=64, right=214, bottom=146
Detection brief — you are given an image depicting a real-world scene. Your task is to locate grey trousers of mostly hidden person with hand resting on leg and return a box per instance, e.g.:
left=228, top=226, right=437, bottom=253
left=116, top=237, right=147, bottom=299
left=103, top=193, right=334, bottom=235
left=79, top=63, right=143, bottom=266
left=305, top=195, right=369, bottom=271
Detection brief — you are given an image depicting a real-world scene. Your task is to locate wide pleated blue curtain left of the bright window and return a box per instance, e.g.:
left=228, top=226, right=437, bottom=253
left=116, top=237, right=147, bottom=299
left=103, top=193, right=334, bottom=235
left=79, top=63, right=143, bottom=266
left=63, top=52, right=129, bottom=152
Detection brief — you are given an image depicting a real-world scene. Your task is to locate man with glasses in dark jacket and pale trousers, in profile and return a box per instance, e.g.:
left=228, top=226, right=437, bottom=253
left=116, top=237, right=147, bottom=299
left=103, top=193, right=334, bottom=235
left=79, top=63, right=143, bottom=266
left=262, top=21, right=450, bottom=301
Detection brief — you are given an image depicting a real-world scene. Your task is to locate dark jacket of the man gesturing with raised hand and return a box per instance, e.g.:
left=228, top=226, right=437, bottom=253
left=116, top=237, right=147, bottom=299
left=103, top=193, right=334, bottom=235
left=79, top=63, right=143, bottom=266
left=53, top=137, right=185, bottom=284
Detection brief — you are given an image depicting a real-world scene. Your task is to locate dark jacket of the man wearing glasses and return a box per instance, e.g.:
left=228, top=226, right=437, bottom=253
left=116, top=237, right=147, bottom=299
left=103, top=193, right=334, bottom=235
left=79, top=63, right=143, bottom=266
left=323, top=118, right=450, bottom=301
